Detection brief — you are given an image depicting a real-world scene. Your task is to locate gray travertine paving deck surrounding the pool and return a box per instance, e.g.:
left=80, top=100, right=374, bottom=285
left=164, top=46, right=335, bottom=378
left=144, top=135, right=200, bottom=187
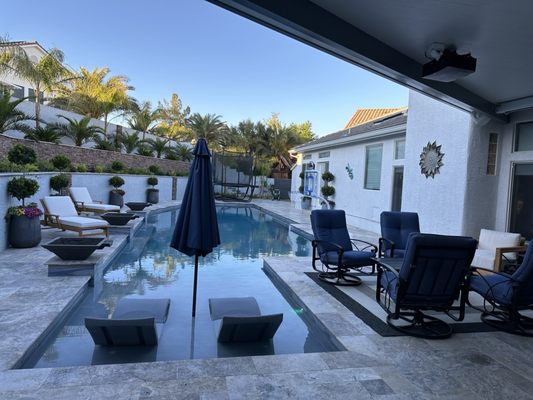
left=0, top=200, right=533, bottom=400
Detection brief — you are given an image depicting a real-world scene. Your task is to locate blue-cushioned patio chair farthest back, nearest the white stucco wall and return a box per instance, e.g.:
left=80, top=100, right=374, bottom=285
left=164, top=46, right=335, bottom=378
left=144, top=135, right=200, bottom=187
left=379, top=211, right=420, bottom=258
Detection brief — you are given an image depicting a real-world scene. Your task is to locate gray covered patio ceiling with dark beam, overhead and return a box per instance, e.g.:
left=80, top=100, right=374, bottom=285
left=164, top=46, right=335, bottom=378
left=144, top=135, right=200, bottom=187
left=208, top=0, right=533, bottom=120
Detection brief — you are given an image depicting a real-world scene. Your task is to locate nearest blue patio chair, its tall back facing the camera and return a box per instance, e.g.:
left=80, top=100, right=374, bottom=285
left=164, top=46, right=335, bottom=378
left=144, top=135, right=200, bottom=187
left=376, top=233, right=477, bottom=339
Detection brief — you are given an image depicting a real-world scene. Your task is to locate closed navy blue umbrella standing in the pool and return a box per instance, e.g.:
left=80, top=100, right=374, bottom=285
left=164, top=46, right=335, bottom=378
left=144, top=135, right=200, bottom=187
left=170, top=139, right=220, bottom=317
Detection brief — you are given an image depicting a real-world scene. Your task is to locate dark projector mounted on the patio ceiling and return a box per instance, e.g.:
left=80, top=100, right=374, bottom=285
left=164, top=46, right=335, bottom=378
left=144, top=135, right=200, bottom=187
left=422, top=49, right=477, bottom=82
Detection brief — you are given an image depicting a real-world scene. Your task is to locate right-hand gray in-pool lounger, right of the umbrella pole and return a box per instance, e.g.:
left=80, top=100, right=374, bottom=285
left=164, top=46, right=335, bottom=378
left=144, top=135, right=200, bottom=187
left=209, top=297, right=283, bottom=342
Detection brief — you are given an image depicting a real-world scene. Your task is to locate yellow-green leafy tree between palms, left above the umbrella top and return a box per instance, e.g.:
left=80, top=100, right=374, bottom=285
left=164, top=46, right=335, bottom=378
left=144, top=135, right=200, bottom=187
left=157, top=93, right=191, bottom=140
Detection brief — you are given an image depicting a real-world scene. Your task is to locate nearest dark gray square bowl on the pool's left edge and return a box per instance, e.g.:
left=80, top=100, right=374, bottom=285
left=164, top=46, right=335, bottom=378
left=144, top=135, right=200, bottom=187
left=42, top=238, right=113, bottom=260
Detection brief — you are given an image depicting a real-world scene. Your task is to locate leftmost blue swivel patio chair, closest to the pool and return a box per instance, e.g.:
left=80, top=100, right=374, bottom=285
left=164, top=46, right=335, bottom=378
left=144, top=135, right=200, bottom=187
left=311, top=210, right=377, bottom=285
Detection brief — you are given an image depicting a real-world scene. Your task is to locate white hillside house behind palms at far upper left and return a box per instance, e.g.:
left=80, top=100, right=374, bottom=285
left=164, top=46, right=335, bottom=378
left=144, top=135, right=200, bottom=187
left=0, top=41, right=47, bottom=103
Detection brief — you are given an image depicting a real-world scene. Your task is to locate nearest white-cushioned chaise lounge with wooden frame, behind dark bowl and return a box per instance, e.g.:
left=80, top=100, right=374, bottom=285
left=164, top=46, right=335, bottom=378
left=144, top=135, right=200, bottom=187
left=41, top=196, right=109, bottom=236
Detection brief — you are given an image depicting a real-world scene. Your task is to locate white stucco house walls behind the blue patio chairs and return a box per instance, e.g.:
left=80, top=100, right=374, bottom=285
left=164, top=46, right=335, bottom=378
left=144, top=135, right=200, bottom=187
left=292, top=91, right=533, bottom=239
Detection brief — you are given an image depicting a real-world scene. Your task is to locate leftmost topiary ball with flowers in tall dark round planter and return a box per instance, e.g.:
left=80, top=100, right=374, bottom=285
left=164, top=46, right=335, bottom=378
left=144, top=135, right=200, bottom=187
left=6, top=176, right=42, bottom=248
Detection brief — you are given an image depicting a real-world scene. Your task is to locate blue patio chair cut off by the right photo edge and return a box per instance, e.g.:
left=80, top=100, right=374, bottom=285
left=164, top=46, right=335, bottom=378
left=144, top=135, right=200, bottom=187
left=468, top=244, right=533, bottom=336
